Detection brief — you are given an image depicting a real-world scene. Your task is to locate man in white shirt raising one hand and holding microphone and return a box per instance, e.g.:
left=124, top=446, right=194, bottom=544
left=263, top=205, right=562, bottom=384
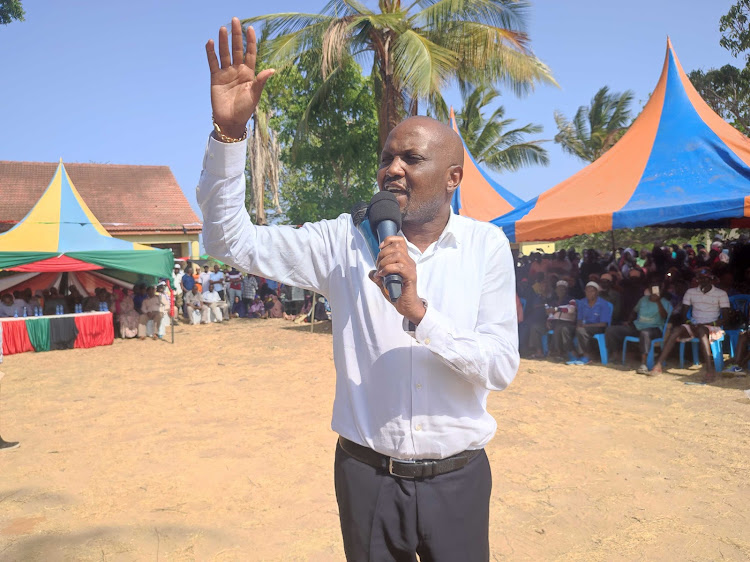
left=197, top=18, right=519, bottom=562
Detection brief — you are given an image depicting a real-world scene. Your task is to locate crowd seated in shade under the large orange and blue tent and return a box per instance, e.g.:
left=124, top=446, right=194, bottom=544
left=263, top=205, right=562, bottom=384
left=516, top=236, right=750, bottom=382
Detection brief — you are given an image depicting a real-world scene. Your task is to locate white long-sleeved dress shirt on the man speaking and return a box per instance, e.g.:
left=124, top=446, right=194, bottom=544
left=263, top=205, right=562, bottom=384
left=197, top=138, right=519, bottom=459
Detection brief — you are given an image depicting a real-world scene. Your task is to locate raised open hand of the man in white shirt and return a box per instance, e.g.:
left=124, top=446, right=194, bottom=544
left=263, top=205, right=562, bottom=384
left=206, top=18, right=275, bottom=138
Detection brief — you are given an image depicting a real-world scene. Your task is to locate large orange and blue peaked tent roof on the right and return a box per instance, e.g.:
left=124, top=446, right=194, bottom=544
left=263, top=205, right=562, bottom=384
left=491, top=39, right=750, bottom=242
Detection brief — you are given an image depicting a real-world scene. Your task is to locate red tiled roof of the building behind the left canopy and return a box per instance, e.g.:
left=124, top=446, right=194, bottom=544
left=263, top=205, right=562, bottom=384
left=0, top=160, right=203, bottom=236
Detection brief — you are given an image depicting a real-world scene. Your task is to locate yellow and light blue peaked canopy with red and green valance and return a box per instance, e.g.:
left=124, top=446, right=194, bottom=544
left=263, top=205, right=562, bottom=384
left=0, top=160, right=174, bottom=277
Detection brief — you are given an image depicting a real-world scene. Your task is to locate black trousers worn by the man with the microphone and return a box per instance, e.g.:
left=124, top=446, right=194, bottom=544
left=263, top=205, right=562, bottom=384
left=334, top=444, right=492, bottom=562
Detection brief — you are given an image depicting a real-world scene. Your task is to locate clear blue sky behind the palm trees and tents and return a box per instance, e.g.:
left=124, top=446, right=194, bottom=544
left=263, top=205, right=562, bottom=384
left=0, top=0, right=737, bottom=219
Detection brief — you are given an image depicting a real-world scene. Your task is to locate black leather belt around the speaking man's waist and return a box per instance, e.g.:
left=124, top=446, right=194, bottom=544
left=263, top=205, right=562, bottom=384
left=339, top=437, right=483, bottom=478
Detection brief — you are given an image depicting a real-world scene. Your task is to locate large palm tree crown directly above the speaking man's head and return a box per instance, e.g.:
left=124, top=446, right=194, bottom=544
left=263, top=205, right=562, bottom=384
left=243, top=0, right=554, bottom=147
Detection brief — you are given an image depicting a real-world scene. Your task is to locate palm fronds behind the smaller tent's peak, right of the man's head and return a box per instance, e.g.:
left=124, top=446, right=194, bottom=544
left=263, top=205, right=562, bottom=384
left=456, top=86, right=549, bottom=172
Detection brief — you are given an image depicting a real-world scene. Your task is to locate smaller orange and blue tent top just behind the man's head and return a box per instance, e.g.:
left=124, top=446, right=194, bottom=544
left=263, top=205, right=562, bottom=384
left=450, top=108, right=524, bottom=222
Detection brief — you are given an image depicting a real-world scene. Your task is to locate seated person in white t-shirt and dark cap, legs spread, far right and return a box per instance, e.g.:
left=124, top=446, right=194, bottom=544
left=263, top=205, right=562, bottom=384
left=649, top=268, right=729, bottom=382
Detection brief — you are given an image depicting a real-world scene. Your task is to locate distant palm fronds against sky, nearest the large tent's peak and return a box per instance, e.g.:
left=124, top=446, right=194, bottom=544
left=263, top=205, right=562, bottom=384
left=555, top=86, right=633, bottom=162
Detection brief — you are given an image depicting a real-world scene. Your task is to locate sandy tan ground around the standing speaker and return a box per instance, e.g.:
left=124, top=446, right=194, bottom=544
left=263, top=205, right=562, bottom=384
left=0, top=320, right=750, bottom=562
